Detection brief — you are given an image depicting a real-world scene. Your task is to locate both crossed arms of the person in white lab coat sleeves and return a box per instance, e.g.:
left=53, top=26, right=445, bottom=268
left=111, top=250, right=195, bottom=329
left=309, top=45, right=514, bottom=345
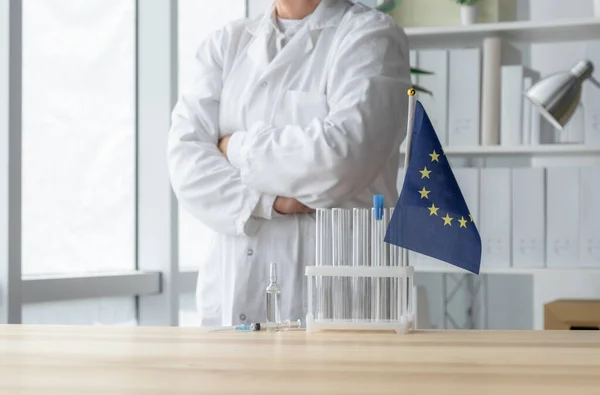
left=169, top=19, right=410, bottom=235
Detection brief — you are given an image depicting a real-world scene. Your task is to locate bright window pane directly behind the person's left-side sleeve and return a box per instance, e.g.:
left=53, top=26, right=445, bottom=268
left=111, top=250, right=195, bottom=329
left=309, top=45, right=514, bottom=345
left=178, top=0, right=246, bottom=270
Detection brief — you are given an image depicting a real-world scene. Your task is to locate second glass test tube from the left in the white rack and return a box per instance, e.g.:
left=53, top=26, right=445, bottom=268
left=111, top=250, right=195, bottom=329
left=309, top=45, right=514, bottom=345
left=332, top=208, right=352, bottom=320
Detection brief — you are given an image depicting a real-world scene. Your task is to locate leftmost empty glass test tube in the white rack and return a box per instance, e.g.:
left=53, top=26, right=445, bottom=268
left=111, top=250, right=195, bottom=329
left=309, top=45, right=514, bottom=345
left=314, top=209, right=332, bottom=320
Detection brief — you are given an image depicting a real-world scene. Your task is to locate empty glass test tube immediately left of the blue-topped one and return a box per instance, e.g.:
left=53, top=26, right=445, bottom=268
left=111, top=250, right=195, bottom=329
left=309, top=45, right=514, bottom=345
left=352, top=208, right=371, bottom=321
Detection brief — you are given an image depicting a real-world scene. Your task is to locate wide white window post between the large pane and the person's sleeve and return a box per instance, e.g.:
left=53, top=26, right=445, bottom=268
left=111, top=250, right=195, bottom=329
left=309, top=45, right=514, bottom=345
left=136, top=0, right=179, bottom=326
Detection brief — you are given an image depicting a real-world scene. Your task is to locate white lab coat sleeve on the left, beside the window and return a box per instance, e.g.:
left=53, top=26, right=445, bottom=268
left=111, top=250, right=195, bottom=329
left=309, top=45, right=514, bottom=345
left=168, top=29, right=274, bottom=235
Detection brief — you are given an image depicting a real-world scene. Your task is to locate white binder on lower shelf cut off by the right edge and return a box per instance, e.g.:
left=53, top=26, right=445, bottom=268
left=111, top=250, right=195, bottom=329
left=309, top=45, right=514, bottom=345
left=579, top=166, right=600, bottom=268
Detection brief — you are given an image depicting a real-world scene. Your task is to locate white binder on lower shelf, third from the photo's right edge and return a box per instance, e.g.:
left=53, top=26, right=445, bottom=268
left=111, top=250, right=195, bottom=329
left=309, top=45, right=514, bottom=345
left=512, top=168, right=546, bottom=268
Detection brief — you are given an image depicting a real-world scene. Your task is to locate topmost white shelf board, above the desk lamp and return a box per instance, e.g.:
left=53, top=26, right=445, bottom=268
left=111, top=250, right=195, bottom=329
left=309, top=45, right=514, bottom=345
left=406, top=18, right=600, bottom=50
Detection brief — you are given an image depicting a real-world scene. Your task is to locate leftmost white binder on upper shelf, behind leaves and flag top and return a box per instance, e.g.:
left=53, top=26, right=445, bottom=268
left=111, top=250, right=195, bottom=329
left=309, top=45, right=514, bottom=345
left=417, top=50, right=448, bottom=146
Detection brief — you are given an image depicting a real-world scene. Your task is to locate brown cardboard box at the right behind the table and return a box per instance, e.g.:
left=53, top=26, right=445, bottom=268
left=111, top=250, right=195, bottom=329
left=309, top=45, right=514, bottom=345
left=544, top=299, right=600, bottom=330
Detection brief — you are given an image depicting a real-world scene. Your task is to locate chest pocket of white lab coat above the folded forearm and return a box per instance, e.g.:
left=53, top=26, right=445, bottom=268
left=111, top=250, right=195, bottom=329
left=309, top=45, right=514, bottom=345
left=273, top=90, right=329, bottom=127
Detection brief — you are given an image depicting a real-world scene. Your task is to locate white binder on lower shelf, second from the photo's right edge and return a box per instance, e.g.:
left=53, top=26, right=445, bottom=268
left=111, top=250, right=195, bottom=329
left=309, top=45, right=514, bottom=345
left=546, top=167, right=580, bottom=267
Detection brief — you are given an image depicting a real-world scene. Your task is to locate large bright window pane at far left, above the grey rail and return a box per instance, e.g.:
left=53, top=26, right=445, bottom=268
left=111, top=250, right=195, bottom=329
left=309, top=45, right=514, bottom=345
left=22, top=0, right=135, bottom=276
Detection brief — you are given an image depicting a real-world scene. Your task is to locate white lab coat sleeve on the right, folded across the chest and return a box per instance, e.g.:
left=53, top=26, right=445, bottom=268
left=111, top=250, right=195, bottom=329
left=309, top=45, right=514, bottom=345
left=229, top=13, right=411, bottom=208
